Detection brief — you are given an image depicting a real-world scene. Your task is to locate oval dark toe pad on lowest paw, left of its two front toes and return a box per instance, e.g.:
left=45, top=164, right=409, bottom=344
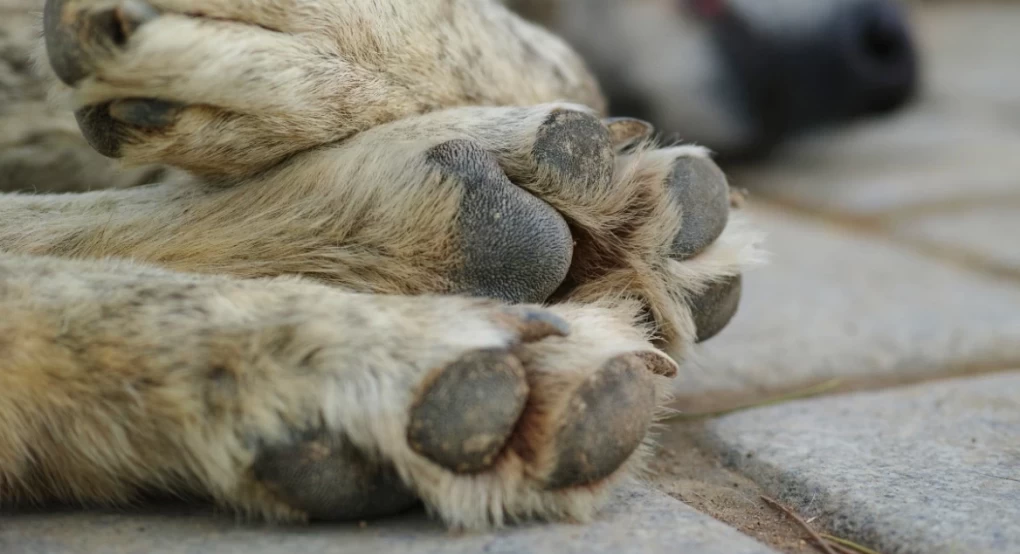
left=407, top=349, right=528, bottom=473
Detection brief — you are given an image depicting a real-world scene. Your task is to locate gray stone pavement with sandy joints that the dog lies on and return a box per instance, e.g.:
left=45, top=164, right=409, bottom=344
left=0, top=2, right=1020, bottom=554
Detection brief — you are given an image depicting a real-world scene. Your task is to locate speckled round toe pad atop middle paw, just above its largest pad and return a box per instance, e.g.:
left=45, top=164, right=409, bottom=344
left=532, top=109, right=615, bottom=190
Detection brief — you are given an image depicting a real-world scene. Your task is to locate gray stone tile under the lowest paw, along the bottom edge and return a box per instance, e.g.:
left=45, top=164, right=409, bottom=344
left=0, top=487, right=776, bottom=554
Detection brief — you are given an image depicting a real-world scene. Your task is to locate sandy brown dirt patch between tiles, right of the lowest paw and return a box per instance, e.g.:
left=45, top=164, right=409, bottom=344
left=651, top=421, right=818, bottom=554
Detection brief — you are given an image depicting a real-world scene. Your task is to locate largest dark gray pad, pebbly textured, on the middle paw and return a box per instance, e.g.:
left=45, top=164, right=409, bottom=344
left=427, top=140, right=573, bottom=303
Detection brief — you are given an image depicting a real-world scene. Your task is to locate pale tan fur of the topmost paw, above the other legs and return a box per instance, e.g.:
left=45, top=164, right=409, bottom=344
left=39, top=0, right=603, bottom=177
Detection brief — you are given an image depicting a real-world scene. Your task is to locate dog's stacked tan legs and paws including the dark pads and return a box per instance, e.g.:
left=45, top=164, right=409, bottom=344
left=0, top=0, right=756, bottom=527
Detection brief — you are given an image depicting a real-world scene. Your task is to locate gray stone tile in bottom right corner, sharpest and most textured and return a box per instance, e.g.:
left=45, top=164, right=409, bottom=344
left=707, top=371, right=1020, bottom=554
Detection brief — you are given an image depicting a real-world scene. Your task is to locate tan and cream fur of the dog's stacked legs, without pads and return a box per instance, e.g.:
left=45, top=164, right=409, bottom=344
left=0, top=0, right=757, bottom=527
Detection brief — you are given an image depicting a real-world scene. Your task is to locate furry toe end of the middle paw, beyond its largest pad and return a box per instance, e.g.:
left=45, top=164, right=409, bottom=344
left=409, top=104, right=760, bottom=356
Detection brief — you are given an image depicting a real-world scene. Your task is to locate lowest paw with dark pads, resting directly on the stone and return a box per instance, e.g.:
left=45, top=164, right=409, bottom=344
left=204, top=298, right=675, bottom=528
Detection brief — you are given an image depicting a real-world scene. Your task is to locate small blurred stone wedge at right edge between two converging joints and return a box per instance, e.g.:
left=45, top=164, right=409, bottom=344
left=894, top=206, right=1020, bottom=269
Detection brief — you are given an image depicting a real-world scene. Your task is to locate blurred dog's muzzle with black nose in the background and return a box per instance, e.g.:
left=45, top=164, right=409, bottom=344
left=510, top=0, right=919, bottom=161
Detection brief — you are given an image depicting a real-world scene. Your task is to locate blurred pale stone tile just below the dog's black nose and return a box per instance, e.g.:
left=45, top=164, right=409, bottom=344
left=730, top=106, right=1020, bottom=216
